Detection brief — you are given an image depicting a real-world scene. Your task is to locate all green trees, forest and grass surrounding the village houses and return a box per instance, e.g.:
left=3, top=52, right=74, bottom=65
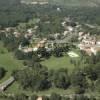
left=0, top=0, right=100, bottom=100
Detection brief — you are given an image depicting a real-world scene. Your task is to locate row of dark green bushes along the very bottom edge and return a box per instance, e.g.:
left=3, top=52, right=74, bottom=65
left=1, top=93, right=96, bottom=100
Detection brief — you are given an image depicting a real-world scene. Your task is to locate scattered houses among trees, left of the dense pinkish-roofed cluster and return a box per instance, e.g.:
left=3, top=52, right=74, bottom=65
left=0, top=17, right=81, bottom=53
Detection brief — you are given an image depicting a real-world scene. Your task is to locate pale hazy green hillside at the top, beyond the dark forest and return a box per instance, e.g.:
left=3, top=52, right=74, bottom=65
left=23, top=0, right=100, bottom=7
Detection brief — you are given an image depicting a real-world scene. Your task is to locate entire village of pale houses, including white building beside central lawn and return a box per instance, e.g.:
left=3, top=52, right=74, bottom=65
left=0, top=16, right=100, bottom=57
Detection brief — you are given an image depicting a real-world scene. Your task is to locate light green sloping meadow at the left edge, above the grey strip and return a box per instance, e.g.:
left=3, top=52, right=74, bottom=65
left=0, top=42, right=23, bottom=83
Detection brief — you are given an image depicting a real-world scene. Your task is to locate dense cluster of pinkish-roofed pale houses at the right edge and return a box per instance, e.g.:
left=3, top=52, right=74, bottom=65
left=78, top=32, right=100, bottom=55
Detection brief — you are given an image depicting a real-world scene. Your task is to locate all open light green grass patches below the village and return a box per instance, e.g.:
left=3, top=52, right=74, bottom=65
left=0, top=42, right=79, bottom=95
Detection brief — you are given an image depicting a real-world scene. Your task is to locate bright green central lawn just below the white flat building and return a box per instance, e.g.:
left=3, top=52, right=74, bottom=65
left=41, top=55, right=76, bottom=71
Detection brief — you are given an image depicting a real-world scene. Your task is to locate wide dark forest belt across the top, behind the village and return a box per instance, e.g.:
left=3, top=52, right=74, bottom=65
left=0, top=0, right=100, bottom=27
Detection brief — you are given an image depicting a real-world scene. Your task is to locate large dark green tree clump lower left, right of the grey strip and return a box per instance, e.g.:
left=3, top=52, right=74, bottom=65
left=13, top=65, right=51, bottom=91
